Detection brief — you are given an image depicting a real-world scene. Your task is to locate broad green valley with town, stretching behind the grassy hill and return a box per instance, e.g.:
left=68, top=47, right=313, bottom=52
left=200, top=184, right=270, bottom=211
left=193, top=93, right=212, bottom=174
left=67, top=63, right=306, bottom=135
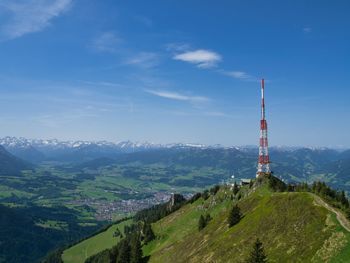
left=0, top=147, right=348, bottom=262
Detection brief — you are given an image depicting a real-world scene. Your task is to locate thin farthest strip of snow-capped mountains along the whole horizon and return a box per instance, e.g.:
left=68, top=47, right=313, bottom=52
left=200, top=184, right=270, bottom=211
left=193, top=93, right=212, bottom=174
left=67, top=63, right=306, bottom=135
left=0, top=136, right=350, bottom=163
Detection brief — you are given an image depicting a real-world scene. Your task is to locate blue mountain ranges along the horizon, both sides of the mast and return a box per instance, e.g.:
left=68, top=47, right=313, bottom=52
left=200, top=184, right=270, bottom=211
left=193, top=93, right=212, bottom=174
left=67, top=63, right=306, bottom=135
left=0, top=137, right=350, bottom=190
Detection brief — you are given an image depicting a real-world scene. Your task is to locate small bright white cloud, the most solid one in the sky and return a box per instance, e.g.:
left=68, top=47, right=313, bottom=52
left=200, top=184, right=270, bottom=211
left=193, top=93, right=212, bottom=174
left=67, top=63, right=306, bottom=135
left=173, top=49, right=222, bottom=68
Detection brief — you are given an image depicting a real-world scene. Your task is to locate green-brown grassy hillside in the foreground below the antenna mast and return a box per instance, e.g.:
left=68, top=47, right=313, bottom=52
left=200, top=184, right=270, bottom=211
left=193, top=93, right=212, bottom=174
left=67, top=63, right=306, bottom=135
left=143, top=186, right=350, bottom=262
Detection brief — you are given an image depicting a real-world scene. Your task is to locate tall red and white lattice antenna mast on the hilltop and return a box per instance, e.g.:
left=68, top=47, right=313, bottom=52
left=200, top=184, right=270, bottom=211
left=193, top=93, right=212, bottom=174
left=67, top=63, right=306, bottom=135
left=256, top=79, right=271, bottom=177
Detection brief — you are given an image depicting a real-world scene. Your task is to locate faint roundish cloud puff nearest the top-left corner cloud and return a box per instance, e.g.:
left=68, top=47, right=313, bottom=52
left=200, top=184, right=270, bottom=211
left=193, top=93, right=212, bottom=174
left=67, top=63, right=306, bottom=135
left=92, top=32, right=123, bottom=53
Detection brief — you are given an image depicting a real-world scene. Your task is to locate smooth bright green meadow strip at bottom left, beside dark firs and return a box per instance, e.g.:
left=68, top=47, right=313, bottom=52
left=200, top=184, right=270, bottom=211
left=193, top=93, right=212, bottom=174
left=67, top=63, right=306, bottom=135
left=62, top=219, right=132, bottom=263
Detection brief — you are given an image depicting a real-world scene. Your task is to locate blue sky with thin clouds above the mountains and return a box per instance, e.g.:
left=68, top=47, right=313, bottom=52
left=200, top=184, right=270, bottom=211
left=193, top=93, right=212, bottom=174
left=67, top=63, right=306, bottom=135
left=0, top=0, right=350, bottom=147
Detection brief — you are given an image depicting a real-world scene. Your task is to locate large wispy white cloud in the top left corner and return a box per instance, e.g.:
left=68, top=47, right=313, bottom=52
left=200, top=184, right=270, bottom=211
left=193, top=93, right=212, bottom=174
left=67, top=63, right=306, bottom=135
left=0, top=0, right=72, bottom=39
